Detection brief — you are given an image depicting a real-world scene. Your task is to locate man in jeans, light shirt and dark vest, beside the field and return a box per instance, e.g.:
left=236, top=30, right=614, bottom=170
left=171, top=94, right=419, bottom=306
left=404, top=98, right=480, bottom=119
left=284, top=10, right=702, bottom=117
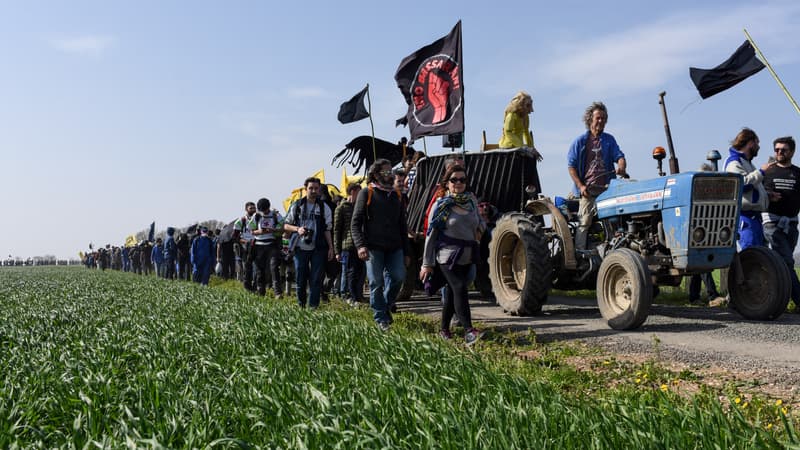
left=284, top=177, right=333, bottom=309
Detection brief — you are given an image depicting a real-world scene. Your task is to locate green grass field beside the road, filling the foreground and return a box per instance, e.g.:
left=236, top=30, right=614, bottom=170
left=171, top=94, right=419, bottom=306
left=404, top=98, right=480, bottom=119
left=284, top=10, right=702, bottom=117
left=0, top=268, right=800, bottom=449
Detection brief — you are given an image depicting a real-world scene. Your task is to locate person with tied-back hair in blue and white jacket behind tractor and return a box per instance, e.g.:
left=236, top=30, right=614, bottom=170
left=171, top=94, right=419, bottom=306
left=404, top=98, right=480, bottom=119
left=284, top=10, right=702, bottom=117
left=725, top=128, right=775, bottom=251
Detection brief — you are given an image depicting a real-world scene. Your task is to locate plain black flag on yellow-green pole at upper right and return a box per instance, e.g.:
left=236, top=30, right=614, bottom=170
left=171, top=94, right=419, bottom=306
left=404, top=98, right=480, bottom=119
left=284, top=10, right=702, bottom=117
left=689, top=41, right=764, bottom=98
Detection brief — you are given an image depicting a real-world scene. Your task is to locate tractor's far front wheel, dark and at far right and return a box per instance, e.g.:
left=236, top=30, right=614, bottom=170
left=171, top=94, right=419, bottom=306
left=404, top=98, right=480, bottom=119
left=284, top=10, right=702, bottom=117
left=728, top=247, right=792, bottom=320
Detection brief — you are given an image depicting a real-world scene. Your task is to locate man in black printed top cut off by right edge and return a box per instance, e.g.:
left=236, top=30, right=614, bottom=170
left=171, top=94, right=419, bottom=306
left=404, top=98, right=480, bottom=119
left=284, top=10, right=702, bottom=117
left=761, top=136, right=800, bottom=312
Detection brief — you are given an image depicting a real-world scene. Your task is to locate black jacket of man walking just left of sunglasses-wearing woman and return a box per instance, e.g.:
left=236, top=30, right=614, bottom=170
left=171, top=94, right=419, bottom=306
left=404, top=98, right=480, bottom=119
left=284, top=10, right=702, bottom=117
left=350, top=188, right=410, bottom=255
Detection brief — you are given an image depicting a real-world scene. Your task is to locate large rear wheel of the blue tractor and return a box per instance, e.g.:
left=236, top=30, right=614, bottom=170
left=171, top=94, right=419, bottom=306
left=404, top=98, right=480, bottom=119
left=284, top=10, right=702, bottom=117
left=489, top=213, right=552, bottom=316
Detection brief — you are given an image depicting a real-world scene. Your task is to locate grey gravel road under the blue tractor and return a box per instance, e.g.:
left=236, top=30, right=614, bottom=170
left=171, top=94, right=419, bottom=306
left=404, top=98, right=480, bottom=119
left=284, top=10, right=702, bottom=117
left=400, top=297, right=800, bottom=397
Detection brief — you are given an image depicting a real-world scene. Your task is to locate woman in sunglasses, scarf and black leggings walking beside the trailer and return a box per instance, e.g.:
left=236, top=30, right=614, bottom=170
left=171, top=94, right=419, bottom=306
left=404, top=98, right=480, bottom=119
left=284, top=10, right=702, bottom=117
left=419, top=165, right=485, bottom=345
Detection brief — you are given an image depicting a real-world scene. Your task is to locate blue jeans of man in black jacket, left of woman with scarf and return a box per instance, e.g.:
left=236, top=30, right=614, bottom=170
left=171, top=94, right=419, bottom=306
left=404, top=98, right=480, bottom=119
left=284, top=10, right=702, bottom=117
left=367, top=248, right=406, bottom=323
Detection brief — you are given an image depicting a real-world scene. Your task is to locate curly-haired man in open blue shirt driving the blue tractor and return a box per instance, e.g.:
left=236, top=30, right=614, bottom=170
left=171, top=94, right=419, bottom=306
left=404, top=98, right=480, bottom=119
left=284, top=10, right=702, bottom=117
left=567, top=102, right=627, bottom=250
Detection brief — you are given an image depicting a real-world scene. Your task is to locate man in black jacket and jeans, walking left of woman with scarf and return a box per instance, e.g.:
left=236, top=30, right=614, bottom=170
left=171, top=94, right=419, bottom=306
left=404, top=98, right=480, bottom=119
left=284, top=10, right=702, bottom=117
left=350, top=159, right=410, bottom=331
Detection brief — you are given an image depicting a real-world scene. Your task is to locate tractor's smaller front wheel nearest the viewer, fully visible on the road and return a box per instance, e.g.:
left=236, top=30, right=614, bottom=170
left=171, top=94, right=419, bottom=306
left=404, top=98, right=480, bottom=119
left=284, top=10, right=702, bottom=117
left=597, top=248, right=653, bottom=330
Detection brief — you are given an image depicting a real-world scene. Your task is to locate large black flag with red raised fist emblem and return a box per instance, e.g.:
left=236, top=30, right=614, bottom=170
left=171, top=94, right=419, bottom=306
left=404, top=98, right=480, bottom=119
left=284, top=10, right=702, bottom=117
left=394, top=20, right=464, bottom=142
